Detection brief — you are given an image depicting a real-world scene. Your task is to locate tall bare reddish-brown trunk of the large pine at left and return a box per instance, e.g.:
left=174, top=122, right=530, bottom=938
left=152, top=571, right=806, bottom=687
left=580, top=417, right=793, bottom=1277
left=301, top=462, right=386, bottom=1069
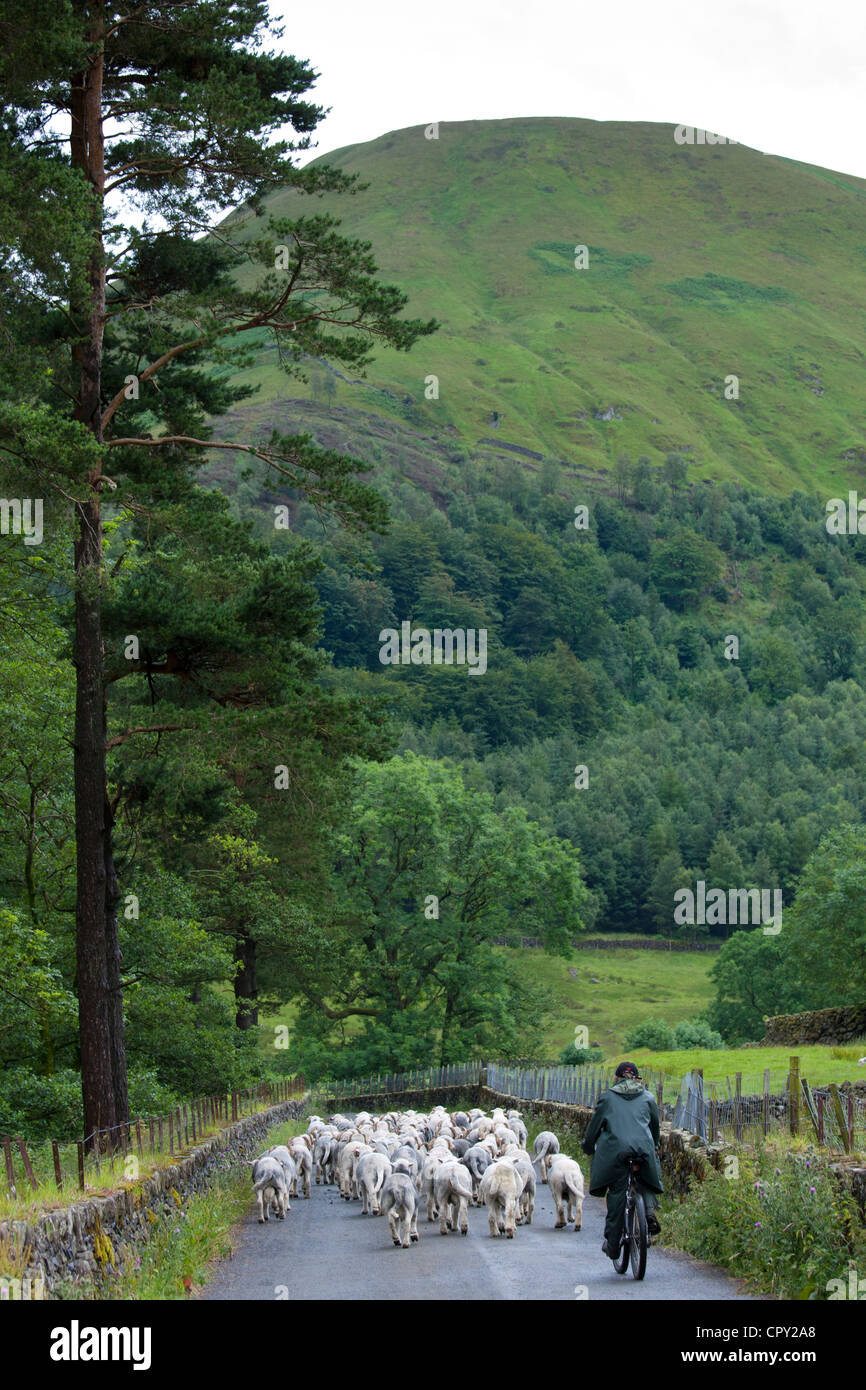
left=70, top=21, right=128, bottom=1134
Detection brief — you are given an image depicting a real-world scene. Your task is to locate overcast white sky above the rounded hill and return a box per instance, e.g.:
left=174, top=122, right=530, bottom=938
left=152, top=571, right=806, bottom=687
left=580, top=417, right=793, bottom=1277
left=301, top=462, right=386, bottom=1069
left=271, top=0, right=866, bottom=178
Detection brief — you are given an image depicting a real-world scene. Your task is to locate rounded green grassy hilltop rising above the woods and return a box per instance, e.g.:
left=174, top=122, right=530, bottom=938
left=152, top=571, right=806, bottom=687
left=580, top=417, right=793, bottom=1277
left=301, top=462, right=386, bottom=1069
left=222, top=118, right=866, bottom=495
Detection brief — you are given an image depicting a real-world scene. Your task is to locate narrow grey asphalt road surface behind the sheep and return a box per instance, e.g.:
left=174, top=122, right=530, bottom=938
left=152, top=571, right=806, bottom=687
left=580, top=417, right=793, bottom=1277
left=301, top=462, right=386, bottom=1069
left=200, top=1183, right=749, bottom=1302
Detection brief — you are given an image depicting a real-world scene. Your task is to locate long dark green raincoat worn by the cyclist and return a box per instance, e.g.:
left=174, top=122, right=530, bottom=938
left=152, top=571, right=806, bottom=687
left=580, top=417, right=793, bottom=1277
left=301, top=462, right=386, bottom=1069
left=581, top=1077, right=664, bottom=1197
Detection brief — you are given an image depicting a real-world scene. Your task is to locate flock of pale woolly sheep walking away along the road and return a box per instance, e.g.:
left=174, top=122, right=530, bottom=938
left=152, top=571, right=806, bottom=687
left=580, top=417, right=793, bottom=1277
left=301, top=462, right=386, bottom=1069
left=253, top=1105, right=584, bottom=1248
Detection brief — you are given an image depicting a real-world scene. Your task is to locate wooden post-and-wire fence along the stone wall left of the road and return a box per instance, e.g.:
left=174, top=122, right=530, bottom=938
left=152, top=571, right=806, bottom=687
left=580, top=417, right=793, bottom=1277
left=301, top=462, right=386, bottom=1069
left=0, top=1076, right=304, bottom=1198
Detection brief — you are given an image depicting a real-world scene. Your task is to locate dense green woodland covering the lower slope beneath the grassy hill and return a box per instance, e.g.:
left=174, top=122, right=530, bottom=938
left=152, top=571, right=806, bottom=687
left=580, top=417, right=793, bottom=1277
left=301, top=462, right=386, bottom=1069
left=0, top=439, right=866, bottom=1125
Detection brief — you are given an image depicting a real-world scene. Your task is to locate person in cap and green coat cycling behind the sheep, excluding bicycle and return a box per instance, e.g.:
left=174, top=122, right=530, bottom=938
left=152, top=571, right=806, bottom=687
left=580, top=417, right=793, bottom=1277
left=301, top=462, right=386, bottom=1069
left=581, top=1062, right=664, bottom=1259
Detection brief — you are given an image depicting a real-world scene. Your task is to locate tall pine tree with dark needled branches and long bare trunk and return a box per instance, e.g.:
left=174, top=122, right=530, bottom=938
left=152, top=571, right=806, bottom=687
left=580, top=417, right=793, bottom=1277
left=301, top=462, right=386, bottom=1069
left=0, top=0, right=435, bottom=1134
